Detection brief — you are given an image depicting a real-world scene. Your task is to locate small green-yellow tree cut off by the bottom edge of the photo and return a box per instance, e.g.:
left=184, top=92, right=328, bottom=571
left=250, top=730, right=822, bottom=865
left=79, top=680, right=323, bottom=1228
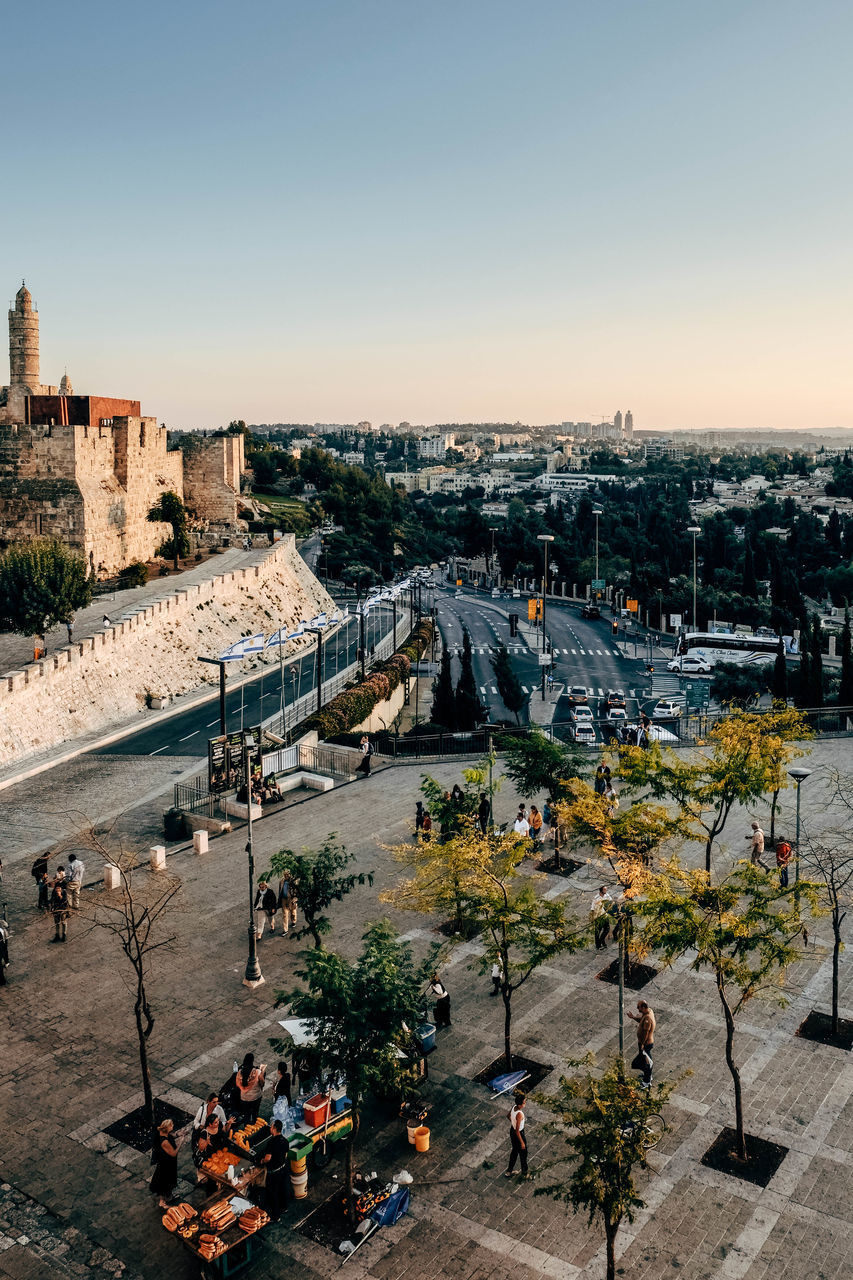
left=533, top=1057, right=678, bottom=1280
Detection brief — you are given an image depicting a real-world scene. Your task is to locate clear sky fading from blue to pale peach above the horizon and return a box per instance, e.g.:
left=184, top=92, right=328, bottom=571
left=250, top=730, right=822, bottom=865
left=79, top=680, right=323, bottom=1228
left=0, top=0, right=853, bottom=430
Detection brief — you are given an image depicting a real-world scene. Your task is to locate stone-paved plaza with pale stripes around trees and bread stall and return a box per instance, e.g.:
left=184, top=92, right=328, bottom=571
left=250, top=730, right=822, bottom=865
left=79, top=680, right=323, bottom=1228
left=0, top=742, right=853, bottom=1280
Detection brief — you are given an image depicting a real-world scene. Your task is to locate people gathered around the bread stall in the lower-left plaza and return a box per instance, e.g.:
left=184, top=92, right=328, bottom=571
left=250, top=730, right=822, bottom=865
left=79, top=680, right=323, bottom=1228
left=149, top=1053, right=293, bottom=1221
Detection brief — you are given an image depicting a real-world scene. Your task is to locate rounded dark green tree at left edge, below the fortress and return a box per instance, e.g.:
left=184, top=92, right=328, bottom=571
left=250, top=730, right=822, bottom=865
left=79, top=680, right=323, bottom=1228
left=0, top=538, right=92, bottom=636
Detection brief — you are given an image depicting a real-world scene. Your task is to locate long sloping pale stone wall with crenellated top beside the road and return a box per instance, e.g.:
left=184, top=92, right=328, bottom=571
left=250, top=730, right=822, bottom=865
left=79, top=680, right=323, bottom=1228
left=0, top=534, right=334, bottom=764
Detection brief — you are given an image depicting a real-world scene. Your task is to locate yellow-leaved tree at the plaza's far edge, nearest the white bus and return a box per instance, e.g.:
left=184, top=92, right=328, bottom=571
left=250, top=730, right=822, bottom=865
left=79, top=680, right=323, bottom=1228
left=616, top=708, right=811, bottom=876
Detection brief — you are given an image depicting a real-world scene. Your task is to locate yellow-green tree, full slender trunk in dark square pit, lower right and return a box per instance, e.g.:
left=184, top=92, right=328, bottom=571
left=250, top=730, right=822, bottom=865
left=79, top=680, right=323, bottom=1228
left=634, top=859, right=818, bottom=1161
